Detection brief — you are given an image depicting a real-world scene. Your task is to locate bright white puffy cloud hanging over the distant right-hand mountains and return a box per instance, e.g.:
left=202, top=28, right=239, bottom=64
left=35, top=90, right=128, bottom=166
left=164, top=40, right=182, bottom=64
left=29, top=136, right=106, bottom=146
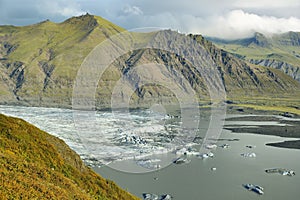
left=196, top=10, right=300, bottom=39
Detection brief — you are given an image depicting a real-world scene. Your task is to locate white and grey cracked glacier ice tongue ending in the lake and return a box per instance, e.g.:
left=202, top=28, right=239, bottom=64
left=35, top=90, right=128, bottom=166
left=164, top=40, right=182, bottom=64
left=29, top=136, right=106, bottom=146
left=0, top=106, right=197, bottom=168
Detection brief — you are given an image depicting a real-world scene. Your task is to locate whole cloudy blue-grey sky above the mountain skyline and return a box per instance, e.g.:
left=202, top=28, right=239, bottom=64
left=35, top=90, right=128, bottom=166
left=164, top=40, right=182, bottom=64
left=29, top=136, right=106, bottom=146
left=0, top=0, right=300, bottom=39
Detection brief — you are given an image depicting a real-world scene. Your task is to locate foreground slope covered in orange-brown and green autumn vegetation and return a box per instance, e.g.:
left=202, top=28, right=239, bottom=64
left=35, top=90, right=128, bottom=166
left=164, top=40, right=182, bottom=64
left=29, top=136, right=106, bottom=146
left=0, top=114, right=137, bottom=200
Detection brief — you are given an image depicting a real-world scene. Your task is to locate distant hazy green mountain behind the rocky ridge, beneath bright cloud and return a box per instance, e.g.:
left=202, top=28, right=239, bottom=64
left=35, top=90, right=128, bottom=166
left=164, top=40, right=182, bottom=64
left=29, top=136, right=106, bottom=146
left=208, top=32, right=300, bottom=81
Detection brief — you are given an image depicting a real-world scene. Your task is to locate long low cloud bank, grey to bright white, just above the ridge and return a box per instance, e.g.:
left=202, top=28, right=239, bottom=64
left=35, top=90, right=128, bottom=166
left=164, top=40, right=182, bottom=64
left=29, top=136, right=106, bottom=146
left=116, top=10, right=300, bottom=39
